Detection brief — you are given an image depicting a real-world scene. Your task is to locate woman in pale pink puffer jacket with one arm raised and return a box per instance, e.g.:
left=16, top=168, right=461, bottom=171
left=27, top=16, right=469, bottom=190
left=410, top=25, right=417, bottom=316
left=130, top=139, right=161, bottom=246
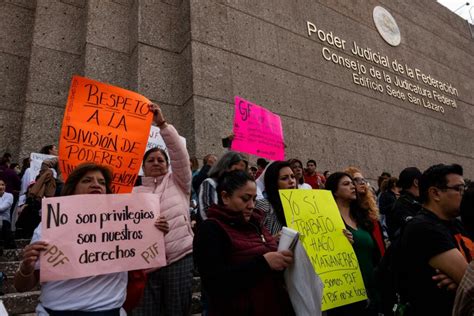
left=132, top=104, right=194, bottom=316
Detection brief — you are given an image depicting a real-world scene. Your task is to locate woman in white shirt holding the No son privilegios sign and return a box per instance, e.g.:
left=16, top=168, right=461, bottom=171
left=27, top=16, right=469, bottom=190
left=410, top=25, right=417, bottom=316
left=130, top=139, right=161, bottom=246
left=14, top=163, right=127, bottom=316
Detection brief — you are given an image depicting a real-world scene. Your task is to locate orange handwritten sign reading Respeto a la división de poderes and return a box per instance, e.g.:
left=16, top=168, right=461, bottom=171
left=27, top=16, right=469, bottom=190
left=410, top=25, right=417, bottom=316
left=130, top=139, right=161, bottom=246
left=59, top=76, right=153, bottom=193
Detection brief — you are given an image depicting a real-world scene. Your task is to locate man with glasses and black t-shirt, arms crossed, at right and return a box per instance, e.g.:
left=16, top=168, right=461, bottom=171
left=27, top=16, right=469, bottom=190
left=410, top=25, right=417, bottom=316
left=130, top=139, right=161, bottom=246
left=397, top=164, right=474, bottom=316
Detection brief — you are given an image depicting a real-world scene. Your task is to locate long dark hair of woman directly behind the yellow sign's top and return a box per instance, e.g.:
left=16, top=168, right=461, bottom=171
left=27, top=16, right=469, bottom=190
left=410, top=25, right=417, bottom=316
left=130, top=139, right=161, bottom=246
left=263, top=161, right=291, bottom=226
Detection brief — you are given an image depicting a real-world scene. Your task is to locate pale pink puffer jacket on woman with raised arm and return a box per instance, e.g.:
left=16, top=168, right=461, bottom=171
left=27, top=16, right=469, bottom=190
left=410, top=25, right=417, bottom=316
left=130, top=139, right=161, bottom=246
left=133, top=125, right=194, bottom=264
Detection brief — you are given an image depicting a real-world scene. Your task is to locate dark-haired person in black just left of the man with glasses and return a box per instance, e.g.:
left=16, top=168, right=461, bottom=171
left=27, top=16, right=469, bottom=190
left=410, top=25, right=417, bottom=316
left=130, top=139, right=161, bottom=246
left=385, top=167, right=421, bottom=241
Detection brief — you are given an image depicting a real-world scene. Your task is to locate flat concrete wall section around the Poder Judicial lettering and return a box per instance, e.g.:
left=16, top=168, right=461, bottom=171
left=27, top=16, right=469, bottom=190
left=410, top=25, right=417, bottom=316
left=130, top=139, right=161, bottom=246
left=191, top=0, right=474, bottom=179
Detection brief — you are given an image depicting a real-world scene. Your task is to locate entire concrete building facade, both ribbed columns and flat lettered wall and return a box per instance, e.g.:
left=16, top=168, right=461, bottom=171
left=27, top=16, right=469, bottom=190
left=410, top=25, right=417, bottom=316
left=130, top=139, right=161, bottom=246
left=0, top=0, right=474, bottom=179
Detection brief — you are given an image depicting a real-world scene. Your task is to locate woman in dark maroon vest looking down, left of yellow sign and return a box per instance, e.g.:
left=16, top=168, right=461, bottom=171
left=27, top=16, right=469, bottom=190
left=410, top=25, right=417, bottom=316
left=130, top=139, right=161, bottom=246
left=194, top=170, right=294, bottom=316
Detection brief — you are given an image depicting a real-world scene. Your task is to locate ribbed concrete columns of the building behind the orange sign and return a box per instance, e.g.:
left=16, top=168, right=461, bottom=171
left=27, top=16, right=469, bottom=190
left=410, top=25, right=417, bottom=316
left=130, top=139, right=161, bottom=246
left=0, top=0, right=194, bottom=159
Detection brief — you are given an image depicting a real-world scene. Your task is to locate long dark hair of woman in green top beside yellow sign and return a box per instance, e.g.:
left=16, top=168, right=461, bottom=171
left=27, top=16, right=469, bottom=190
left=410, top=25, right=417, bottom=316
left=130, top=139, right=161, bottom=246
left=324, top=172, right=374, bottom=232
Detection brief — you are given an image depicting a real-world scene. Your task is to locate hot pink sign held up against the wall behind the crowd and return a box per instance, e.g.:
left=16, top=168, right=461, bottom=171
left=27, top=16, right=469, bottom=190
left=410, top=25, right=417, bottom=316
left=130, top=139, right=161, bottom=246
left=231, top=96, right=285, bottom=160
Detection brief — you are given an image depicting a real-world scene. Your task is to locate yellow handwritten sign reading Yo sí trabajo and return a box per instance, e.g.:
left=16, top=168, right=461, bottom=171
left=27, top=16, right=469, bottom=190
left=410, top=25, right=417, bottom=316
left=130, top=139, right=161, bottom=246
left=280, top=190, right=367, bottom=311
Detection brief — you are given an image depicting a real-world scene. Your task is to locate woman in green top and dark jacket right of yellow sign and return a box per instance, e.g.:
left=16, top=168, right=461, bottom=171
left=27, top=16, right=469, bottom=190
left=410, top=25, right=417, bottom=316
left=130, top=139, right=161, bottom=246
left=326, top=172, right=383, bottom=316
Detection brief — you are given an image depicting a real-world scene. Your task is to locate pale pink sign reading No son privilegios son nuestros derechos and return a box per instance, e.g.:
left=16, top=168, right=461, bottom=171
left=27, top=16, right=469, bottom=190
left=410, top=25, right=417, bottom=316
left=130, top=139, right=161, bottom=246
left=40, top=193, right=166, bottom=282
